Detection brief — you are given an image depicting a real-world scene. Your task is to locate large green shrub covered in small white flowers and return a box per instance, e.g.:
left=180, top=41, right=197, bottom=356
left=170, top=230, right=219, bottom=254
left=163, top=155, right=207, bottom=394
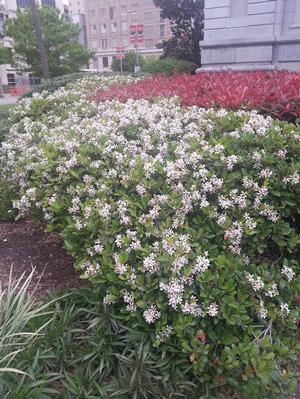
left=1, top=78, right=300, bottom=398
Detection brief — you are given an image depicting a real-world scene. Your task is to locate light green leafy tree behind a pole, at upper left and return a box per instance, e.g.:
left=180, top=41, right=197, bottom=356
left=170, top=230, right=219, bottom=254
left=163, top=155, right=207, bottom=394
left=5, top=6, right=93, bottom=77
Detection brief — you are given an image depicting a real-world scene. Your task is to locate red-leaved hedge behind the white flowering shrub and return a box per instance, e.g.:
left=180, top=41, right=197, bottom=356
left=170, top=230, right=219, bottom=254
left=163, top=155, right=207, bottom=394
left=95, top=71, right=300, bottom=122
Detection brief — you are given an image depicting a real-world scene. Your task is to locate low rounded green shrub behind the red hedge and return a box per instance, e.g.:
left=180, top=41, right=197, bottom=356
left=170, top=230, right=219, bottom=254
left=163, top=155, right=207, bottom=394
left=142, top=57, right=197, bottom=75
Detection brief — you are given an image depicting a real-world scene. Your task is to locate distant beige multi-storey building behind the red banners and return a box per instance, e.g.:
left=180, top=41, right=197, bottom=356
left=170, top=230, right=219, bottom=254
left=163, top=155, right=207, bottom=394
left=85, top=0, right=171, bottom=71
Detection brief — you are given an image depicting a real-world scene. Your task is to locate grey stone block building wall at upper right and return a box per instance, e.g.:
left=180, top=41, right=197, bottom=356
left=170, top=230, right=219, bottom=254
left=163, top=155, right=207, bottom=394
left=201, top=0, right=300, bottom=70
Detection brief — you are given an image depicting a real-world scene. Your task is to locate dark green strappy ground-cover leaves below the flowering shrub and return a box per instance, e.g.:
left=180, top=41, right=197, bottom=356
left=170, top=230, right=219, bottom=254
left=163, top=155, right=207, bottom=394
left=0, top=288, right=199, bottom=399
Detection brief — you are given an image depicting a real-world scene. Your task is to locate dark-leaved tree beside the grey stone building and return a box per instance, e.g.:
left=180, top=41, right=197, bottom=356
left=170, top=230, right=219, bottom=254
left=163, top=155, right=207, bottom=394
left=154, top=0, right=204, bottom=65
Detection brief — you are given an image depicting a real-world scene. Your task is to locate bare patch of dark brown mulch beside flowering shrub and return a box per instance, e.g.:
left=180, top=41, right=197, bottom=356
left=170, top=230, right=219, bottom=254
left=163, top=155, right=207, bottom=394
left=0, top=220, right=84, bottom=295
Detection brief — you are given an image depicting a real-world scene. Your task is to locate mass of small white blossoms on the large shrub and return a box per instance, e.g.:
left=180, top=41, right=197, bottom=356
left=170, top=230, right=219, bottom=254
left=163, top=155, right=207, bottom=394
left=0, top=77, right=299, bottom=339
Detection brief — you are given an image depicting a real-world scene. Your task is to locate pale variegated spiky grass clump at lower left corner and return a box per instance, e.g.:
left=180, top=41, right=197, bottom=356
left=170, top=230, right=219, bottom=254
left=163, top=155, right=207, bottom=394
left=0, top=269, right=59, bottom=399
